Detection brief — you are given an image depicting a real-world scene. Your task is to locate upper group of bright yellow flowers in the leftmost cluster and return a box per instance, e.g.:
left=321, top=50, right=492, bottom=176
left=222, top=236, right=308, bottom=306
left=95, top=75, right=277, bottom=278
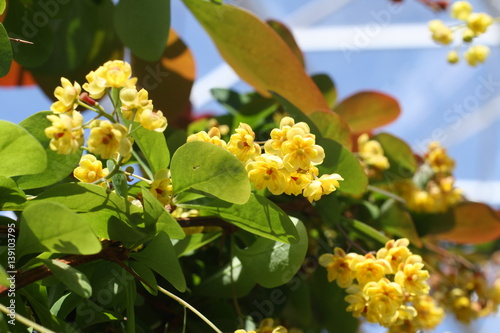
left=45, top=60, right=167, bottom=160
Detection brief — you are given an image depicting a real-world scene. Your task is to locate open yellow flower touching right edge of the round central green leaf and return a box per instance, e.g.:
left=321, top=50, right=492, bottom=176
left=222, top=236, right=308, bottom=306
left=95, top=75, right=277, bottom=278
left=245, top=154, right=287, bottom=195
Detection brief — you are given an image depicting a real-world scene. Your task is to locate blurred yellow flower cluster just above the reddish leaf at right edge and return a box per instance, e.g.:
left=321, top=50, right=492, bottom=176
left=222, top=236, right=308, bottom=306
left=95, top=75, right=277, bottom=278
left=395, top=142, right=463, bottom=213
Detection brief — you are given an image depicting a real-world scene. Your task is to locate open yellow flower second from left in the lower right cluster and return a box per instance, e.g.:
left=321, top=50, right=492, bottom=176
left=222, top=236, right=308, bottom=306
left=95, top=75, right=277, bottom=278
left=350, top=253, right=391, bottom=286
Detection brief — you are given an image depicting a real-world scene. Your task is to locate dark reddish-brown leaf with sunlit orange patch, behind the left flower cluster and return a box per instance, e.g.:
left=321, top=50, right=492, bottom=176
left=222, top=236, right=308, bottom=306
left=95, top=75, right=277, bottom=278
left=132, top=29, right=195, bottom=127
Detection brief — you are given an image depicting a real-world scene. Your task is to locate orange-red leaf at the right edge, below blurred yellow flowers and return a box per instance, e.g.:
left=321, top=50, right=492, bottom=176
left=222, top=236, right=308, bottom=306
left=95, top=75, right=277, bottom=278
left=437, top=202, right=500, bottom=244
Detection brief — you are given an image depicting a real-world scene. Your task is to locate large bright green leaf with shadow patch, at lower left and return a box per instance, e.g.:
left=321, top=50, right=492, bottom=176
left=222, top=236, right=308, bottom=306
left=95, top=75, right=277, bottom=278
left=17, top=202, right=102, bottom=258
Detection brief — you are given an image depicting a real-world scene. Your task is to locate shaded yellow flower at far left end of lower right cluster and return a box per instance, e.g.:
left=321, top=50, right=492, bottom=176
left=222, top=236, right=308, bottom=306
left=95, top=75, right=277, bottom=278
left=319, top=247, right=355, bottom=288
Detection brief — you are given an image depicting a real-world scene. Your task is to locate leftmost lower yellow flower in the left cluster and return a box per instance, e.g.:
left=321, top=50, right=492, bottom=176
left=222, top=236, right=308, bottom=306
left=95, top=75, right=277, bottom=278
left=45, top=111, right=83, bottom=154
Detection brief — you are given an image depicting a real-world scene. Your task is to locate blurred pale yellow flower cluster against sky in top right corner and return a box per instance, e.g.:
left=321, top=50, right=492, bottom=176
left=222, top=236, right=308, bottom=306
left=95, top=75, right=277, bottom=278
left=429, top=1, right=494, bottom=66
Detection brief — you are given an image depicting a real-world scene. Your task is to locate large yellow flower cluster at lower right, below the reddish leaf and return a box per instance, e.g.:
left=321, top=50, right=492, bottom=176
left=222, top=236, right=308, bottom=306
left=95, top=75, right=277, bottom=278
left=319, top=238, right=442, bottom=329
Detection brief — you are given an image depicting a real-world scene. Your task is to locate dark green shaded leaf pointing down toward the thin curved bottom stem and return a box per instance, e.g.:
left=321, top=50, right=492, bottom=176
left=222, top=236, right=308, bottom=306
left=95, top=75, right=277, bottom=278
left=130, top=232, right=186, bottom=292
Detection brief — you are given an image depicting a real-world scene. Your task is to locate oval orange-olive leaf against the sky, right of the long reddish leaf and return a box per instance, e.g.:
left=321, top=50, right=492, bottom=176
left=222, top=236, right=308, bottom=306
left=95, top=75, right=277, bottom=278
left=333, top=91, right=401, bottom=133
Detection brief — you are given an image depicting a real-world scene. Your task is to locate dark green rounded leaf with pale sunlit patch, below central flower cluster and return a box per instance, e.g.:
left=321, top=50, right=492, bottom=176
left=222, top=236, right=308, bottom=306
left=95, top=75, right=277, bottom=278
left=235, top=219, right=308, bottom=288
